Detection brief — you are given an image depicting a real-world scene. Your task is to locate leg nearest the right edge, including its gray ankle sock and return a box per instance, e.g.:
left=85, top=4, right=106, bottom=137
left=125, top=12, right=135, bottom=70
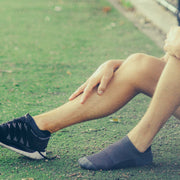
left=79, top=57, right=180, bottom=170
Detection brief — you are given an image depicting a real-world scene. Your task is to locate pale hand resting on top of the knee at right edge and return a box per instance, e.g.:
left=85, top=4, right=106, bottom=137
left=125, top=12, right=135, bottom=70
left=164, top=26, right=180, bottom=59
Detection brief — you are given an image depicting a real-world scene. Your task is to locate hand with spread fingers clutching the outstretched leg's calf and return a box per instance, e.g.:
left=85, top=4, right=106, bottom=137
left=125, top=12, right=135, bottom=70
left=69, top=60, right=122, bottom=104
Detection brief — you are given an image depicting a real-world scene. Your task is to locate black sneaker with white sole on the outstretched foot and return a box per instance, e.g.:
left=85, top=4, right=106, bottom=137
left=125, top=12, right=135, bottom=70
left=0, top=114, right=50, bottom=159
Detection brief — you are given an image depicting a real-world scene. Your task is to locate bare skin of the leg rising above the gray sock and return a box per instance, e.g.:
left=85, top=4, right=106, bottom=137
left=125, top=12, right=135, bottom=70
left=128, top=56, right=180, bottom=152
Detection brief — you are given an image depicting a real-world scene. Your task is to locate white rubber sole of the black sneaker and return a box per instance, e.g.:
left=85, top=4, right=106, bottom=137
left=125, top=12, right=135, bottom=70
left=0, top=142, right=46, bottom=159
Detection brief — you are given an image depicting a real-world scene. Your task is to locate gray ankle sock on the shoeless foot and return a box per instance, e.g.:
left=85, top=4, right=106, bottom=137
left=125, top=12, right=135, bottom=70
left=78, top=136, right=153, bottom=170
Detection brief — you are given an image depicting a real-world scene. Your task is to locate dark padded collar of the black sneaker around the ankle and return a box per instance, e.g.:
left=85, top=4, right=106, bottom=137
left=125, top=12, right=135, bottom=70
left=25, top=114, right=51, bottom=138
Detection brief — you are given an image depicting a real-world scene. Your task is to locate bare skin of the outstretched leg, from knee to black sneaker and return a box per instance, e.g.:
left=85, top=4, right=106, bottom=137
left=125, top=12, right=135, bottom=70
left=34, top=54, right=165, bottom=133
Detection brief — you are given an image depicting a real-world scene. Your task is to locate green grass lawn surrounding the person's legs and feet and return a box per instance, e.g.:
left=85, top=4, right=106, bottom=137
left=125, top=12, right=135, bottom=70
left=0, top=0, right=180, bottom=180
